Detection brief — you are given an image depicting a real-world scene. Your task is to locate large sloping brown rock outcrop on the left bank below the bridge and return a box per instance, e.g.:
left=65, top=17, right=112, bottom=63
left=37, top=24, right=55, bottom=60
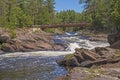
left=2, top=30, right=66, bottom=52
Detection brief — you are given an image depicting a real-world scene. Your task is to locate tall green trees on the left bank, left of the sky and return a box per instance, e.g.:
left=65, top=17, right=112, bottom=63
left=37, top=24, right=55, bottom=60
left=0, top=0, right=55, bottom=28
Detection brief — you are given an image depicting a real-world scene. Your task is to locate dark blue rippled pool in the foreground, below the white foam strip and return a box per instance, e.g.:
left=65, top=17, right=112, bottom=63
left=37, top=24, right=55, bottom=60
left=0, top=56, right=67, bottom=80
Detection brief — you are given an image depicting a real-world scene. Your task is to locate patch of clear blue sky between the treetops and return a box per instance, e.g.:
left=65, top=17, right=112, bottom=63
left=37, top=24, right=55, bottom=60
left=55, top=0, right=84, bottom=12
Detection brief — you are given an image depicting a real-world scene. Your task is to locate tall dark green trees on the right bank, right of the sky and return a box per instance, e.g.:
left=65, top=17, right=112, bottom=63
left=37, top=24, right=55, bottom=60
left=79, top=0, right=120, bottom=31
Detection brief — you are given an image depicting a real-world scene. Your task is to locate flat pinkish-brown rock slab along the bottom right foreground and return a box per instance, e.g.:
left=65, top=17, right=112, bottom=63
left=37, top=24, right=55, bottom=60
left=55, top=67, right=120, bottom=80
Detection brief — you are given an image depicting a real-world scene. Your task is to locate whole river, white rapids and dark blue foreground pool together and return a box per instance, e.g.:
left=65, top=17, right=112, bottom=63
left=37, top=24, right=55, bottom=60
left=0, top=33, right=109, bottom=80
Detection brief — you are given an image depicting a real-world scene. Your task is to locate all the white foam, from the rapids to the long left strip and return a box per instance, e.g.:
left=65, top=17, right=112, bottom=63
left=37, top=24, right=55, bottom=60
left=0, top=33, right=109, bottom=57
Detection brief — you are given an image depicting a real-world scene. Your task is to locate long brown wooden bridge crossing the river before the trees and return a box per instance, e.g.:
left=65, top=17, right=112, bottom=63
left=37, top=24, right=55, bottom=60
left=32, top=22, right=91, bottom=29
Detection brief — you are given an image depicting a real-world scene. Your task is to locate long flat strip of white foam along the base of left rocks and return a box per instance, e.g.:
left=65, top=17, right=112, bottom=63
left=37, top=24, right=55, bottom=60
left=0, top=51, right=73, bottom=57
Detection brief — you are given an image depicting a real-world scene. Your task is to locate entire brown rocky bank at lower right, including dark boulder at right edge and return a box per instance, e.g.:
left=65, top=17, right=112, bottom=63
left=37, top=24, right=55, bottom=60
left=55, top=32, right=120, bottom=80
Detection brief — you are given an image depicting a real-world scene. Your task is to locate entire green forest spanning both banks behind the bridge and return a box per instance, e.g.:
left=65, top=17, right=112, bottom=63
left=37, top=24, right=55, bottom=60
left=0, top=0, right=120, bottom=31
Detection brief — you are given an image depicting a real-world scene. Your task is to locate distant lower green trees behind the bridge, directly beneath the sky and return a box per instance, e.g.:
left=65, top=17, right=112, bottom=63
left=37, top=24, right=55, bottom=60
left=56, top=10, right=83, bottom=32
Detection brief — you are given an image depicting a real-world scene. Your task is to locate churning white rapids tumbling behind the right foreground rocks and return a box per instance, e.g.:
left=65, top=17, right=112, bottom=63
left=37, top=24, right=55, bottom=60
left=67, top=39, right=109, bottom=52
